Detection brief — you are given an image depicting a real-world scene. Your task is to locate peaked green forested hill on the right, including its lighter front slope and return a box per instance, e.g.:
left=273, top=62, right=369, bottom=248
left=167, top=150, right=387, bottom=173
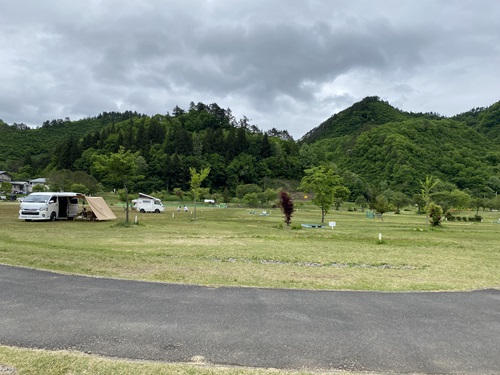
left=301, top=97, right=500, bottom=192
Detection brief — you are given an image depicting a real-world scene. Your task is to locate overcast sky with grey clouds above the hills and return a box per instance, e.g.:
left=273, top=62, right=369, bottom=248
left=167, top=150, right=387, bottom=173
left=0, top=0, right=500, bottom=139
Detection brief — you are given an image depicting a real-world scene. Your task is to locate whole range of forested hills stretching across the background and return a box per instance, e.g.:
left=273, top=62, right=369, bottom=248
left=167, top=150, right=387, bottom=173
left=0, top=97, right=500, bottom=199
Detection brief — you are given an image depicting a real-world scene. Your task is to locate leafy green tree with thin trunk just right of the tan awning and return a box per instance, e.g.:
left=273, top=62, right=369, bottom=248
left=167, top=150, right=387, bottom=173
left=92, top=146, right=143, bottom=224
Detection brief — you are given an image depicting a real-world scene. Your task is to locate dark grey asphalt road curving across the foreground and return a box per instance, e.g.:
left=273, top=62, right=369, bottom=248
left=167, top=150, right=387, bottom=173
left=0, top=265, right=500, bottom=375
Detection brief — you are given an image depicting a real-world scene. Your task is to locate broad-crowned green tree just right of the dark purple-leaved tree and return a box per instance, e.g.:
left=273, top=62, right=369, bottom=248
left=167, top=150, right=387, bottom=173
left=300, top=165, right=343, bottom=223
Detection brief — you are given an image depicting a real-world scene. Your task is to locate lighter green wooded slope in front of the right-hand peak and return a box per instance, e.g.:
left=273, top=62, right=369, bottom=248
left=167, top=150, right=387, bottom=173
left=311, top=118, right=500, bottom=195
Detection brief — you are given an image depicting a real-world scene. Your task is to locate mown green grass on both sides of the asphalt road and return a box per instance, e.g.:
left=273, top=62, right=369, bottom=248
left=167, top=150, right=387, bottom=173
left=0, top=201, right=500, bottom=374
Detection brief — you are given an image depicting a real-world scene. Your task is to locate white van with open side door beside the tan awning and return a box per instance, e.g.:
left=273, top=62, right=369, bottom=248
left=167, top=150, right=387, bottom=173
left=19, top=192, right=83, bottom=221
